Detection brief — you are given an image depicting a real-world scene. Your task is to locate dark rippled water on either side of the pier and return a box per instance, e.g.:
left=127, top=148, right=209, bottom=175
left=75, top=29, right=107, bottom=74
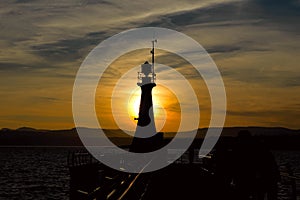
left=0, top=147, right=300, bottom=200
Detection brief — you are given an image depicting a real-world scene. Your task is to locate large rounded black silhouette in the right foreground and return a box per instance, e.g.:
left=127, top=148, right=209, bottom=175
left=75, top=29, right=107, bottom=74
left=215, top=130, right=280, bottom=200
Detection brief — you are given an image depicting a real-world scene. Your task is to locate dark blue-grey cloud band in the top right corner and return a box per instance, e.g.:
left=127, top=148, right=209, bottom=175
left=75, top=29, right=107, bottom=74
left=147, top=0, right=300, bottom=30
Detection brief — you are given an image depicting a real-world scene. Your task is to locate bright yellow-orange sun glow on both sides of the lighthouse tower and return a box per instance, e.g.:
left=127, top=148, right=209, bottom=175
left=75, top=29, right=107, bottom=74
left=99, top=66, right=181, bottom=132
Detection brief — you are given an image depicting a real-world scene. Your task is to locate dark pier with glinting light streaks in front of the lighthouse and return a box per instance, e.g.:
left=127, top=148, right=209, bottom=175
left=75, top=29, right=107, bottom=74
left=68, top=149, right=300, bottom=200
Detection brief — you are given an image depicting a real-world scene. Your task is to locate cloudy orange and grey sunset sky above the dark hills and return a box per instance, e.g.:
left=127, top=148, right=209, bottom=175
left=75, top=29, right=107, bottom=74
left=0, top=0, right=300, bottom=131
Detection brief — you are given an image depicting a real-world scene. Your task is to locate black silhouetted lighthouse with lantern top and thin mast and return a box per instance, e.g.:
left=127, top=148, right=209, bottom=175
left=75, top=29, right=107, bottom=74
left=129, top=40, right=163, bottom=153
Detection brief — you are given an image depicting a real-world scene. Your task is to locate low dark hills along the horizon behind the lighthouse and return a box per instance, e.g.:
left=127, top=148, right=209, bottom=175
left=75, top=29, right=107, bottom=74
left=0, top=127, right=300, bottom=149
